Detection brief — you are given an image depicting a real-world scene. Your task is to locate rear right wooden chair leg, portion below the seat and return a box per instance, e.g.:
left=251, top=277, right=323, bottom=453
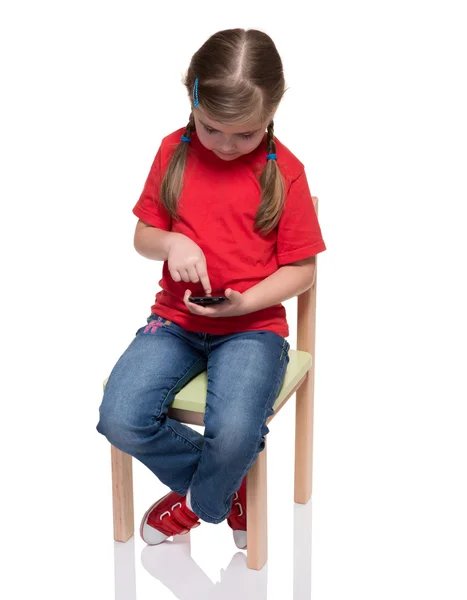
left=294, top=367, right=314, bottom=504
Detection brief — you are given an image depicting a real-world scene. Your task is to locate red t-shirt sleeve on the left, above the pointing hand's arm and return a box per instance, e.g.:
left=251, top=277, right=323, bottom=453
left=133, top=144, right=172, bottom=231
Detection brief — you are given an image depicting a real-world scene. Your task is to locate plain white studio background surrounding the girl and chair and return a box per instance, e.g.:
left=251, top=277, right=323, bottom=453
left=0, top=0, right=467, bottom=600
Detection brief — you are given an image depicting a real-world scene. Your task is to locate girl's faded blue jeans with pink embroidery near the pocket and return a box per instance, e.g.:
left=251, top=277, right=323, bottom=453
left=97, top=314, right=290, bottom=523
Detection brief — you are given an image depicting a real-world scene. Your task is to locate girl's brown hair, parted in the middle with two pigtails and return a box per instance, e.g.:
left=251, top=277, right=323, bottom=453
left=161, top=29, right=286, bottom=234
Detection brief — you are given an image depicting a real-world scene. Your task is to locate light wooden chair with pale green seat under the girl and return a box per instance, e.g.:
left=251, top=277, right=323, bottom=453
left=104, top=196, right=318, bottom=570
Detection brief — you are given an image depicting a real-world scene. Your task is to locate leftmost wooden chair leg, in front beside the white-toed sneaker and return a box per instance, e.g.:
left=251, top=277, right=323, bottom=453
left=110, top=445, right=135, bottom=542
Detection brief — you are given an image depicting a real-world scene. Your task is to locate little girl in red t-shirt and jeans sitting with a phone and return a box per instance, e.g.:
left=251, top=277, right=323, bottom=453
left=97, top=29, right=326, bottom=548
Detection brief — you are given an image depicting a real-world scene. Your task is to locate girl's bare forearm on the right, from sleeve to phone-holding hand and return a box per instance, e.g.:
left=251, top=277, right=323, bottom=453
left=242, top=256, right=316, bottom=313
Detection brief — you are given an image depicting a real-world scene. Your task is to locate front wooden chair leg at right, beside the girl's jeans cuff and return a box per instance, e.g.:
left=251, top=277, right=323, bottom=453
left=246, top=436, right=268, bottom=571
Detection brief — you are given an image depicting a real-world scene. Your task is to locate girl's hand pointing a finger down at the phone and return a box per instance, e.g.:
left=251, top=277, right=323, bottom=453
left=167, top=233, right=211, bottom=296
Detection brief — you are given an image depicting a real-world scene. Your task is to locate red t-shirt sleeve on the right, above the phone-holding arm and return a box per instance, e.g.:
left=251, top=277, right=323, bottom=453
left=277, top=171, right=326, bottom=265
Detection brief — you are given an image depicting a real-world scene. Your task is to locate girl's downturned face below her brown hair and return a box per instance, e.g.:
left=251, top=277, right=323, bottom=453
left=193, top=108, right=271, bottom=161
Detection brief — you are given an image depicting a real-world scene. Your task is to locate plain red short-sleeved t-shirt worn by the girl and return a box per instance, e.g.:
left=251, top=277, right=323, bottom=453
left=133, top=128, right=326, bottom=337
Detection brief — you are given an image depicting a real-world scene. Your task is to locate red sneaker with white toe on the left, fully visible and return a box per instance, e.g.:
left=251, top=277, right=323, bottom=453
left=139, top=492, right=201, bottom=546
